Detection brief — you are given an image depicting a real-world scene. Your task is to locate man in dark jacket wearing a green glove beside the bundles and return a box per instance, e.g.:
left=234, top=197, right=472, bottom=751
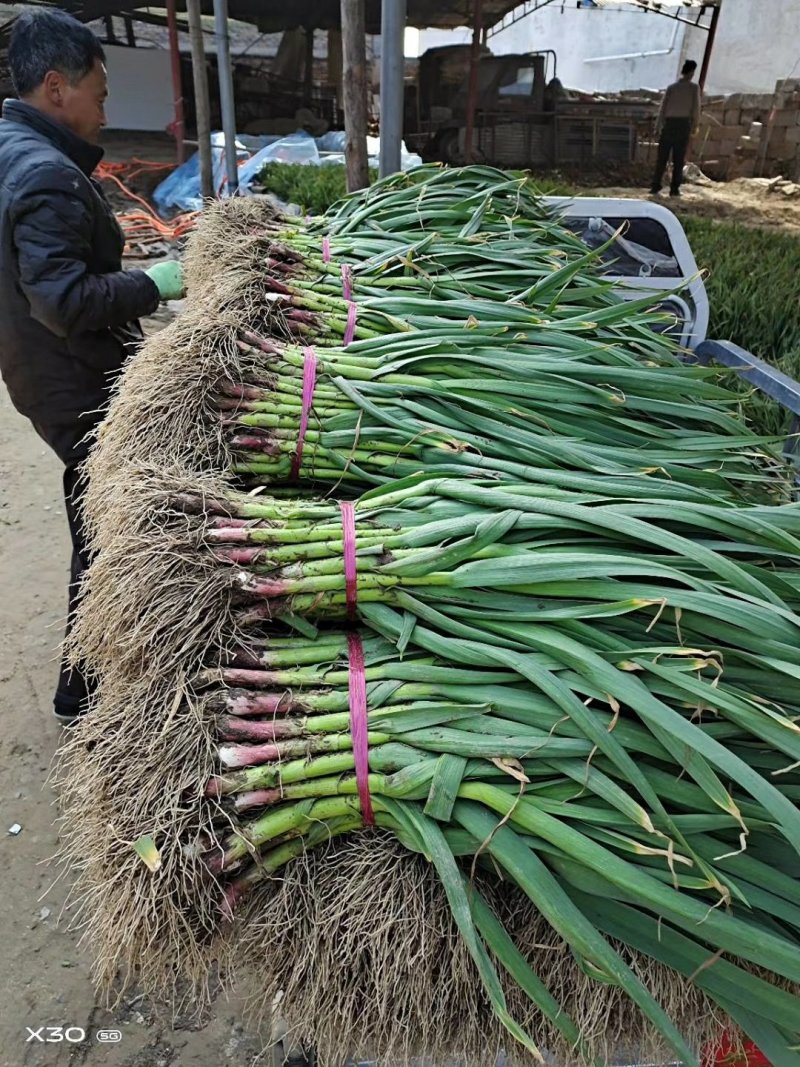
left=0, top=11, right=181, bottom=721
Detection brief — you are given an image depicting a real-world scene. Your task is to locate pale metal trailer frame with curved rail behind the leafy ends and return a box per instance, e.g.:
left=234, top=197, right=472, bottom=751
left=272, top=196, right=800, bottom=1067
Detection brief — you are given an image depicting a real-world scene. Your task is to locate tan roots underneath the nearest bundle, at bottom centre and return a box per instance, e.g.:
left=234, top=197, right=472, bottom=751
left=237, top=831, right=725, bottom=1067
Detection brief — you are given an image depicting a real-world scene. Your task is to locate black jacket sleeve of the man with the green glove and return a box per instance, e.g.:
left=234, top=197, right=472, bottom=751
left=12, top=164, right=159, bottom=337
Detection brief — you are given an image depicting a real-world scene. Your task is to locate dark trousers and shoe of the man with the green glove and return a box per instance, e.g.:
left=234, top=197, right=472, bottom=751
left=33, top=417, right=97, bottom=715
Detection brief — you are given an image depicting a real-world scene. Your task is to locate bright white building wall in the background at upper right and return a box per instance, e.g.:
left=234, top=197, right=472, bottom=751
left=419, top=0, right=800, bottom=93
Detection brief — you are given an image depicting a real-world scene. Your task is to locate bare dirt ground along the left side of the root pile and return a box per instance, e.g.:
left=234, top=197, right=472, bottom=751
left=0, top=296, right=270, bottom=1067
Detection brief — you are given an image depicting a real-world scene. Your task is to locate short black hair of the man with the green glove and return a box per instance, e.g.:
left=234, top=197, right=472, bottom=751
left=9, top=11, right=106, bottom=96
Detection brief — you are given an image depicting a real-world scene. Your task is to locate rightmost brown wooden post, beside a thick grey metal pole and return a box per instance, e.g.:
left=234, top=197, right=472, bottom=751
left=341, top=0, right=369, bottom=192
